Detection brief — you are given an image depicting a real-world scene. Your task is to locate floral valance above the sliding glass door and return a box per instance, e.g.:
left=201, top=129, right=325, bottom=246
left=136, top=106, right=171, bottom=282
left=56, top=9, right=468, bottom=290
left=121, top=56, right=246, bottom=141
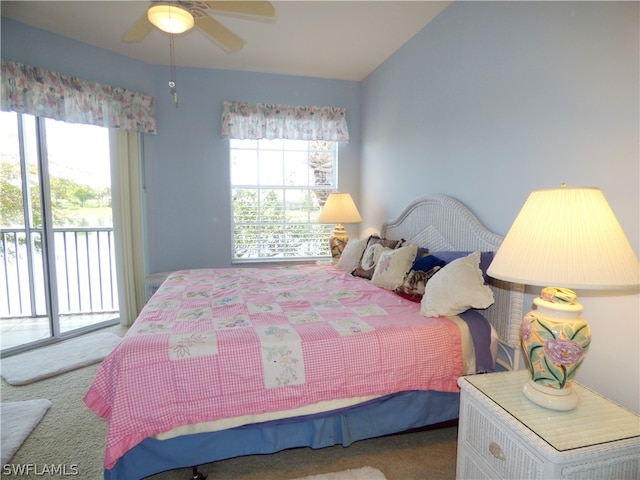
left=1, top=59, right=157, bottom=133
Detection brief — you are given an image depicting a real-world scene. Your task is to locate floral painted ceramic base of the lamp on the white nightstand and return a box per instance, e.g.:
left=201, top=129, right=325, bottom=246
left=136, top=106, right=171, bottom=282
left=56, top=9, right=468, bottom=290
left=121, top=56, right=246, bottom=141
left=520, top=287, right=591, bottom=411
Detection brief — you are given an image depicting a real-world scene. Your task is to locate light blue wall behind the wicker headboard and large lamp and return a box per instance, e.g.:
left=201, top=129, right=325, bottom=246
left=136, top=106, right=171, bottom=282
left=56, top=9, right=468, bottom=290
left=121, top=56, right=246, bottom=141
left=360, top=2, right=640, bottom=411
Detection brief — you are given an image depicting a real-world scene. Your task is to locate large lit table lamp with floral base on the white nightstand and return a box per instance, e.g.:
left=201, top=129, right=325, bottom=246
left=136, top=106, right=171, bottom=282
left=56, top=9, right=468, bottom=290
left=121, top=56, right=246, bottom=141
left=487, top=185, right=640, bottom=411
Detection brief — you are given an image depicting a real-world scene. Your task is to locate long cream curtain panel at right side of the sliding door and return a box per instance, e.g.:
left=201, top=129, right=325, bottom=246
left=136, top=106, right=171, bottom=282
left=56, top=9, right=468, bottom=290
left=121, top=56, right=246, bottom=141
left=109, top=129, right=146, bottom=326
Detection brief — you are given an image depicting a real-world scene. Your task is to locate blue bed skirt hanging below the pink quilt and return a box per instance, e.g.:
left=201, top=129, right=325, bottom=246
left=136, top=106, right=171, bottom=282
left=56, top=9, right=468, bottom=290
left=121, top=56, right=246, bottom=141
left=104, top=391, right=460, bottom=480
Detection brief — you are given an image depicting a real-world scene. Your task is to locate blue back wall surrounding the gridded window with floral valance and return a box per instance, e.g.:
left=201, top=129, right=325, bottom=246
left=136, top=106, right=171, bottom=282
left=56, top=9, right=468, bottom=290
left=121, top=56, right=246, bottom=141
left=145, top=66, right=360, bottom=271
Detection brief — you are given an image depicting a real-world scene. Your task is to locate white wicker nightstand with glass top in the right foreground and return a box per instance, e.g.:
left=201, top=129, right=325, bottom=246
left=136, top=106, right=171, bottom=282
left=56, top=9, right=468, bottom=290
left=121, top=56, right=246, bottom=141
left=456, top=370, right=640, bottom=480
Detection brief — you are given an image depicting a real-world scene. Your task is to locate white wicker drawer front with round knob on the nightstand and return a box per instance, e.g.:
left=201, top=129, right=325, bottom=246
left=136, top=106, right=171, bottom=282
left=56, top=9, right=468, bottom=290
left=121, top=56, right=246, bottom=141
left=463, top=403, right=544, bottom=479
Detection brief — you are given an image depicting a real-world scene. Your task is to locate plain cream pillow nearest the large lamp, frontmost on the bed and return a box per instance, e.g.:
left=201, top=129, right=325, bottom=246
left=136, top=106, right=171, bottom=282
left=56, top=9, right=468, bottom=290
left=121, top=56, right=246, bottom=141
left=420, top=252, right=494, bottom=317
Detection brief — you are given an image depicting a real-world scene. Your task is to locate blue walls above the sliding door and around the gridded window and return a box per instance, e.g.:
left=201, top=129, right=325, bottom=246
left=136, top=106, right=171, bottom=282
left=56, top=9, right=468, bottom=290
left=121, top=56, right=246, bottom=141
left=1, top=17, right=360, bottom=273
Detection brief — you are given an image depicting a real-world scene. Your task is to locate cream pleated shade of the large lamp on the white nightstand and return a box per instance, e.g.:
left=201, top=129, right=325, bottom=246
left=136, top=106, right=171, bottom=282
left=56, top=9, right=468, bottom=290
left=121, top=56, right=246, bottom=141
left=487, top=186, right=640, bottom=290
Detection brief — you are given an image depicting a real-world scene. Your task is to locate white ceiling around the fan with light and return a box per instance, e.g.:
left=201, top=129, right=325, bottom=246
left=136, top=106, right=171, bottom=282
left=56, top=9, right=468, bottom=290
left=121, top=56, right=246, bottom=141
left=0, top=0, right=451, bottom=80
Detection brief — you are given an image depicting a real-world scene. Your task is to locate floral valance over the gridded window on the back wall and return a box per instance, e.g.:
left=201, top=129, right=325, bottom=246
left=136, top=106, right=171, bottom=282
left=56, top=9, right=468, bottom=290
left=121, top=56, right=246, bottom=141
left=222, top=102, right=349, bottom=142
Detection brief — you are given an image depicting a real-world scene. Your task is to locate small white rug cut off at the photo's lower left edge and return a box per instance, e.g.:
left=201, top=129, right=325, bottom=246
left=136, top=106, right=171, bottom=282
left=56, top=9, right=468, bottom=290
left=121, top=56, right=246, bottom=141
left=0, top=399, right=51, bottom=465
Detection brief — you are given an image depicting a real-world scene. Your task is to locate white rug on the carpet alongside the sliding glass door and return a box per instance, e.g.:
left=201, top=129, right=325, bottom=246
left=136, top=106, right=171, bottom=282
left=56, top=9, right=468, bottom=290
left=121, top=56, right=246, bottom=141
left=1, top=332, right=121, bottom=385
